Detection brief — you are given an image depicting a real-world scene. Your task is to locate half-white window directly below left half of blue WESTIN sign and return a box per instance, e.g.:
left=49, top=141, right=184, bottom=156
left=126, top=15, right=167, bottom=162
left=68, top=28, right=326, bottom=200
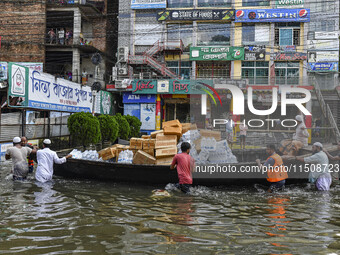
left=242, top=24, right=270, bottom=45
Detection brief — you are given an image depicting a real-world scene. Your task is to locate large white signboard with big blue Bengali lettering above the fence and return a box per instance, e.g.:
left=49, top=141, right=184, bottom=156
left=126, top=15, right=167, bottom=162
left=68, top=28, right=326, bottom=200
left=8, top=63, right=92, bottom=112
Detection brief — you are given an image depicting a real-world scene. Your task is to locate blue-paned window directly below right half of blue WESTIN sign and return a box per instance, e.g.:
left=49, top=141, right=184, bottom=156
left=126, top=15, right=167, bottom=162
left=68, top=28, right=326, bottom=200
left=275, top=23, right=300, bottom=46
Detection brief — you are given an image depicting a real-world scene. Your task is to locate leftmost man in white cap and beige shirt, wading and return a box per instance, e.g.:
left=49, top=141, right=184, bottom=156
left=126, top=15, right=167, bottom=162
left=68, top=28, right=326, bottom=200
left=5, top=137, right=36, bottom=180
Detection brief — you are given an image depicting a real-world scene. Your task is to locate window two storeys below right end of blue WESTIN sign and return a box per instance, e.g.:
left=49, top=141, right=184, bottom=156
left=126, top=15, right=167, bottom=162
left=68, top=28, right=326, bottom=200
left=275, top=62, right=300, bottom=85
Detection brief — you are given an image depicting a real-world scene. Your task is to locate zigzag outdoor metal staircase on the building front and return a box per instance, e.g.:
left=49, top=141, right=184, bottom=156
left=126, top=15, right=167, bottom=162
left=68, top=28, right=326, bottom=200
left=128, top=40, right=183, bottom=79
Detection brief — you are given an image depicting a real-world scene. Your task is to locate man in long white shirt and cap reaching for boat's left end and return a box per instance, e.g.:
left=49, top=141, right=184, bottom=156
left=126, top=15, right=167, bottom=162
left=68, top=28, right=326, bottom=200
left=35, top=139, right=72, bottom=182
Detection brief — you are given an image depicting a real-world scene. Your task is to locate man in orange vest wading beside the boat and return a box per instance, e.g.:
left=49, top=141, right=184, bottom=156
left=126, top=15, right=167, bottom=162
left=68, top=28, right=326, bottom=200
left=256, top=144, right=288, bottom=192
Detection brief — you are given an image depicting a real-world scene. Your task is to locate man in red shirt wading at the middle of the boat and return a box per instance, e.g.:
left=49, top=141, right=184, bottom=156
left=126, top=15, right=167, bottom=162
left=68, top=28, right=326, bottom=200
left=170, top=142, right=195, bottom=193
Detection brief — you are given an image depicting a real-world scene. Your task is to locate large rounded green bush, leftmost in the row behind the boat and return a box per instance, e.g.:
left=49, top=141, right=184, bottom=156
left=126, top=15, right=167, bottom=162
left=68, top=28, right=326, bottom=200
left=67, top=112, right=101, bottom=147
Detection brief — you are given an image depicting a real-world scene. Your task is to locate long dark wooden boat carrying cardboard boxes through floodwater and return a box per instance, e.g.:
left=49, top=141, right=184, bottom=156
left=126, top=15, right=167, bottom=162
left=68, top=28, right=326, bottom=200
left=54, top=146, right=336, bottom=186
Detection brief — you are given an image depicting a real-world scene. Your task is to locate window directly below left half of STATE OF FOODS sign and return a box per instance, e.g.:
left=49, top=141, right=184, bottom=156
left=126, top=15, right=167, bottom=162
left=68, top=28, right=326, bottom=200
left=168, top=24, right=193, bottom=52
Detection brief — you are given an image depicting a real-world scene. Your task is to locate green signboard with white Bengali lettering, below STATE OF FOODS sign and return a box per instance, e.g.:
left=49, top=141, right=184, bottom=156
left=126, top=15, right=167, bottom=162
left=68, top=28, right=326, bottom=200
left=190, top=46, right=244, bottom=61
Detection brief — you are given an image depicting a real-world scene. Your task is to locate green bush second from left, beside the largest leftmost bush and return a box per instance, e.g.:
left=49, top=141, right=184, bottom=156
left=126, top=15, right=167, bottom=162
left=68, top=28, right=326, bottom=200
left=97, top=115, right=119, bottom=142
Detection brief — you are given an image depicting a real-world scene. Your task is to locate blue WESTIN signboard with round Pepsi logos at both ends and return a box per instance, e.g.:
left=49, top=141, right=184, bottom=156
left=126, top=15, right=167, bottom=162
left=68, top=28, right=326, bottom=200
left=235, top=9, right=310, bottom=23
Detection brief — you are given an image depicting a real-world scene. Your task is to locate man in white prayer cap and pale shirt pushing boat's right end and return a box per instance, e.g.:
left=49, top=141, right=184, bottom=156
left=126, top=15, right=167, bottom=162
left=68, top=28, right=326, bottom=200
left=295, top=142, right=332, bottom=190
